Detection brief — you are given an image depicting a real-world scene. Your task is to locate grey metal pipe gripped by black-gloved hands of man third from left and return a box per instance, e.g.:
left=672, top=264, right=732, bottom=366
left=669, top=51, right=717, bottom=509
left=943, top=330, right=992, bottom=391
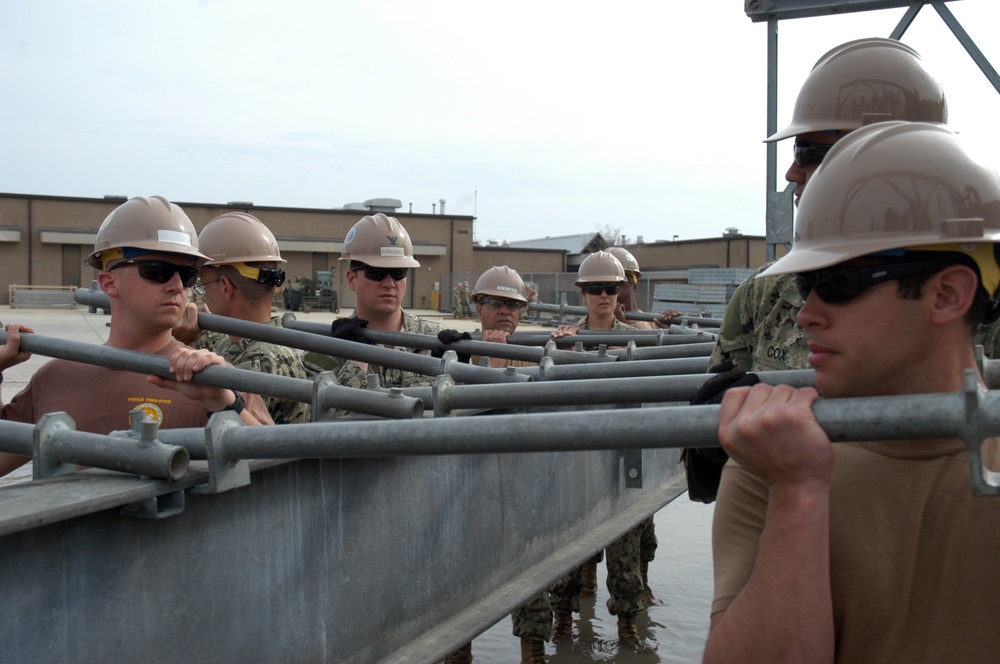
left=278, top=314, right=614, bottom=364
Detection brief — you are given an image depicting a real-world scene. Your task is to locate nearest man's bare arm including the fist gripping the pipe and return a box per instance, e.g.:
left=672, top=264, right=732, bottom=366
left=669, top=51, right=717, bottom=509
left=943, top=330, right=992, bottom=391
left=703, top=385, right=834, bottom=663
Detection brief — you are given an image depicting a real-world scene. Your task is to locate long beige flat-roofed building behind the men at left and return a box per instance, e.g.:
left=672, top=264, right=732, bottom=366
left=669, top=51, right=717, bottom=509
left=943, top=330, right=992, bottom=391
left=0, top=193, right=474, bottom=308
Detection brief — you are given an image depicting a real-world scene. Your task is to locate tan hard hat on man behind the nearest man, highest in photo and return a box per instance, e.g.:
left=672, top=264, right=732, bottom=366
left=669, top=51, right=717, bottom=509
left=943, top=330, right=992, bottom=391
left=765, top=37, right=948, bottom=143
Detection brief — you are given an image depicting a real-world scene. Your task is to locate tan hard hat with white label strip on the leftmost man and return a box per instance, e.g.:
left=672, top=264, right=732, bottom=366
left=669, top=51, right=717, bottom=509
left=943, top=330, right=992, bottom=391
left=86, top=196, right=208, bottom=270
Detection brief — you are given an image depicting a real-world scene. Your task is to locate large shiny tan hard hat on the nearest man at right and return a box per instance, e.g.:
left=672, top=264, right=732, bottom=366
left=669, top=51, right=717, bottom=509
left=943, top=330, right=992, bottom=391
left=759, top=122, right=1000, bottom=277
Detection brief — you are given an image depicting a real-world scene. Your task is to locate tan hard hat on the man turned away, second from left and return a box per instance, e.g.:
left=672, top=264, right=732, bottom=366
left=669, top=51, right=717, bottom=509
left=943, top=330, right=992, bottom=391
left=198, top=212, right=285, bottom=265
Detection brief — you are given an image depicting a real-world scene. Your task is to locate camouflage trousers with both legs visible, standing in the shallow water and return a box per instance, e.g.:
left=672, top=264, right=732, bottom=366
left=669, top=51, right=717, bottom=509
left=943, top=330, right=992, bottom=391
left=549, top=518, right=644, bottom=616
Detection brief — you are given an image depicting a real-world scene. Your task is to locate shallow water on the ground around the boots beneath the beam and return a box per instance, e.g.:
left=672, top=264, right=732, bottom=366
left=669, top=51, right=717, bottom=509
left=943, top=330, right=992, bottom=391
left=472, top=494, right=714, bottom=664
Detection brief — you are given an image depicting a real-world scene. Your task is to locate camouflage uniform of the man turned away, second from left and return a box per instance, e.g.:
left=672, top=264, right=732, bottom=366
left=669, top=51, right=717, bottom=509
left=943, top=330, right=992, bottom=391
left=201, top=316, right=310, bottom=424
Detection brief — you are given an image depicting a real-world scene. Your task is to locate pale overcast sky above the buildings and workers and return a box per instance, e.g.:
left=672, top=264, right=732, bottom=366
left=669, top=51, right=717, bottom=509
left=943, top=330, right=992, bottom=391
left=0, top=0, right=1000, bottom=241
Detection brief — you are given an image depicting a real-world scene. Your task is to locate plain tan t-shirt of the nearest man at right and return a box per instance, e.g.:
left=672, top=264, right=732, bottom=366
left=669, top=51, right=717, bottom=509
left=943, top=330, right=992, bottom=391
left=712, top=441, right=1000, bottom=664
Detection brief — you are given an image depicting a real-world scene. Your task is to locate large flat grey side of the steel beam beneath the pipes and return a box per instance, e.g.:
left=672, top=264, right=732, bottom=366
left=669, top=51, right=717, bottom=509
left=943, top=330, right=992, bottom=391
left=0, top=446, right=680, bottom=663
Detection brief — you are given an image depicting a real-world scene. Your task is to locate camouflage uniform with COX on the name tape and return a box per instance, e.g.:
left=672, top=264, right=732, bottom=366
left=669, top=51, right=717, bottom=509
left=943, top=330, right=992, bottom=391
left=709, top=264, right=809, bottom=371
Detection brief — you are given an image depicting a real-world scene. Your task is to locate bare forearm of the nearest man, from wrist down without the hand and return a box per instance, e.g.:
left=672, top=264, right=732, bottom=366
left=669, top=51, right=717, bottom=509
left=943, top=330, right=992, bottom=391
left=703, top=485, right=834, bottom=663
